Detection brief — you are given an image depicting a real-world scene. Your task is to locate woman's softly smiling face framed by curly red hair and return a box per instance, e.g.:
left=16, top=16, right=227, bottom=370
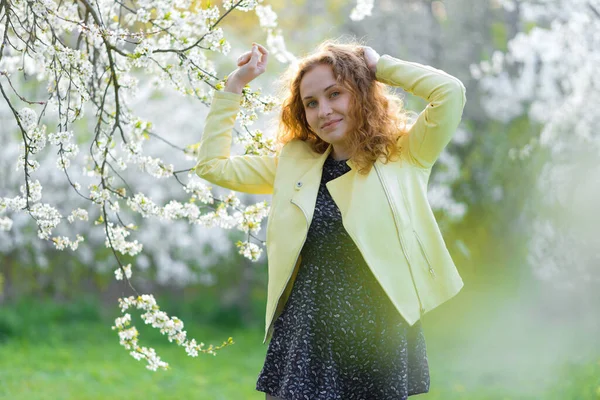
left=300, top=64, right=352, bottom=147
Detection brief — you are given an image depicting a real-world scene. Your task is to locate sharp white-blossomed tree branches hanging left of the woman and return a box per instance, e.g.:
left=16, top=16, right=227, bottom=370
left=0, top=0, right=293, bottom=370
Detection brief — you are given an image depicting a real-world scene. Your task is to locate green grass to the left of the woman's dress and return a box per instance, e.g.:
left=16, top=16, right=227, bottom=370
left=0, top=324, right=266, bottom=400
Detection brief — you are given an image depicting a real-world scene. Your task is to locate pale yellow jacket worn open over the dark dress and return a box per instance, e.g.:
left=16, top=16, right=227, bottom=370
left=196, top=55, right=466, bottom=343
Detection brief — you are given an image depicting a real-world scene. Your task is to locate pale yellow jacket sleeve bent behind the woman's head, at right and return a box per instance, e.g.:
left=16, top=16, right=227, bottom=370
left=376, top=55, right=466, bottom=168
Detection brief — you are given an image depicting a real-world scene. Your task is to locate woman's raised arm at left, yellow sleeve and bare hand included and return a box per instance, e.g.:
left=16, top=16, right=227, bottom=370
left=196, top=45, right=278, bottom=194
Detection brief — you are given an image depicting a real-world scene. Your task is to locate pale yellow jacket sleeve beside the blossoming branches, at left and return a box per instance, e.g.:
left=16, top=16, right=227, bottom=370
left=196, top=91, right=278, bottom=194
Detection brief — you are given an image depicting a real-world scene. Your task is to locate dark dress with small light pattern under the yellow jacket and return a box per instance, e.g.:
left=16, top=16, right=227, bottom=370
left=256, top=152, right=429, bottom=400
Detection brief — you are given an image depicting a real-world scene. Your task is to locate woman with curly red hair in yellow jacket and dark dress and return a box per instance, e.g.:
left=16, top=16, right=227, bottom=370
left=196, top=41, right=465, bottom=400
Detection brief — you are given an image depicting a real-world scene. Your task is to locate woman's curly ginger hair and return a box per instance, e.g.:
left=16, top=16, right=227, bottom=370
left=277, top=39, right=410, bottom=174
